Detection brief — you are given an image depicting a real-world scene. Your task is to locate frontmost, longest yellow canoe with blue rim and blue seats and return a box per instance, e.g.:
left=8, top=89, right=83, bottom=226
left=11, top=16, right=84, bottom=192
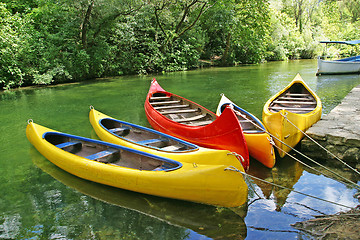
left=26, top=122, right=247, bottom=206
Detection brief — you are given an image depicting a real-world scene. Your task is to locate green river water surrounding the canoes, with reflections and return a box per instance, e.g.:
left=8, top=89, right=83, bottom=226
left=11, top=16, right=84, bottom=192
left=0, top=60, right=360, bottom=239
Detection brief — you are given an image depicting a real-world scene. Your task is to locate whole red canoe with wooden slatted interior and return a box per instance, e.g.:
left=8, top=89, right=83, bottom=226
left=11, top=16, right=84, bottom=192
left=145, top=78, right=249, bottom=169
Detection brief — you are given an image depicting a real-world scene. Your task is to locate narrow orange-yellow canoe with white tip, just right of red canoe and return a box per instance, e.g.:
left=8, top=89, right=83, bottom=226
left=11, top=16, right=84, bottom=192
left=216, top=95, right=275, bottom=168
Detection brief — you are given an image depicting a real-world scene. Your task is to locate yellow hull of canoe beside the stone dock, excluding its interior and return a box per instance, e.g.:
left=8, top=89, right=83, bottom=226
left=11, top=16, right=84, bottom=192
left=263, top=74, right=322, bottom=157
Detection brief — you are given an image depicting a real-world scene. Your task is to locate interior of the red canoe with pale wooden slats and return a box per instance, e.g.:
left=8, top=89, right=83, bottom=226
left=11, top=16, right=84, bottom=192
left=149, top=92, right=216, bottom=126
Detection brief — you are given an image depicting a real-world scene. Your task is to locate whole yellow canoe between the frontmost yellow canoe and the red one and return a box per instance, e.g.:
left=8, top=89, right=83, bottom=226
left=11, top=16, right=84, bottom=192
left=89, top=108, right=243, bottom=168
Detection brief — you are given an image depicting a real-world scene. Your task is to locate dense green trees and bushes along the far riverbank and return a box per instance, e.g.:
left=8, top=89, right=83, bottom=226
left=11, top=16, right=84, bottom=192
left=0, top=0, right=360, bottom=89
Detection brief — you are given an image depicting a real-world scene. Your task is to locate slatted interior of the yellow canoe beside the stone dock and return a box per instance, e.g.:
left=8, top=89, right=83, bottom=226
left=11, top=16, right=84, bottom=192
left=269, top=83, right=317, bottom=114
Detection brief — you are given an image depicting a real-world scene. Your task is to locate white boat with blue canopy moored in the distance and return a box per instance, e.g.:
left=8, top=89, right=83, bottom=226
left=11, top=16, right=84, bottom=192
left=316, top=40, right=360, bottom=76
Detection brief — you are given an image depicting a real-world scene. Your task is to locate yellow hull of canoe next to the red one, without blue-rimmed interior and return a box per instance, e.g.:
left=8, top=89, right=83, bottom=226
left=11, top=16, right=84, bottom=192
left=89, top=109, right=244, bottom=168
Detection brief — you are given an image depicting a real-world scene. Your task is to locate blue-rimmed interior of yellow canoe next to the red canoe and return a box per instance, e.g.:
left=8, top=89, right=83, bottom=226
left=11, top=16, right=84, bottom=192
left=100, top=118, right=198, bottom=151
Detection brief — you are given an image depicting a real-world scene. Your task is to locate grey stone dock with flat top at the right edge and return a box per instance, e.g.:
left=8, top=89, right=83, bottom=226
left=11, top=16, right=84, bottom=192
left=301, top=85, right=360, bottom=169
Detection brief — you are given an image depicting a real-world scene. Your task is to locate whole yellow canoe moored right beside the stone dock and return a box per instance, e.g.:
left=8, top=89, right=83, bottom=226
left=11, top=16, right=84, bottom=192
left=263, top=74, right=322, bottom=157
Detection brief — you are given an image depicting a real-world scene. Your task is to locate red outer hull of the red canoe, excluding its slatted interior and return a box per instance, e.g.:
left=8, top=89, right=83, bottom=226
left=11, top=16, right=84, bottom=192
left=145, top=79, right=249, bottom=169
